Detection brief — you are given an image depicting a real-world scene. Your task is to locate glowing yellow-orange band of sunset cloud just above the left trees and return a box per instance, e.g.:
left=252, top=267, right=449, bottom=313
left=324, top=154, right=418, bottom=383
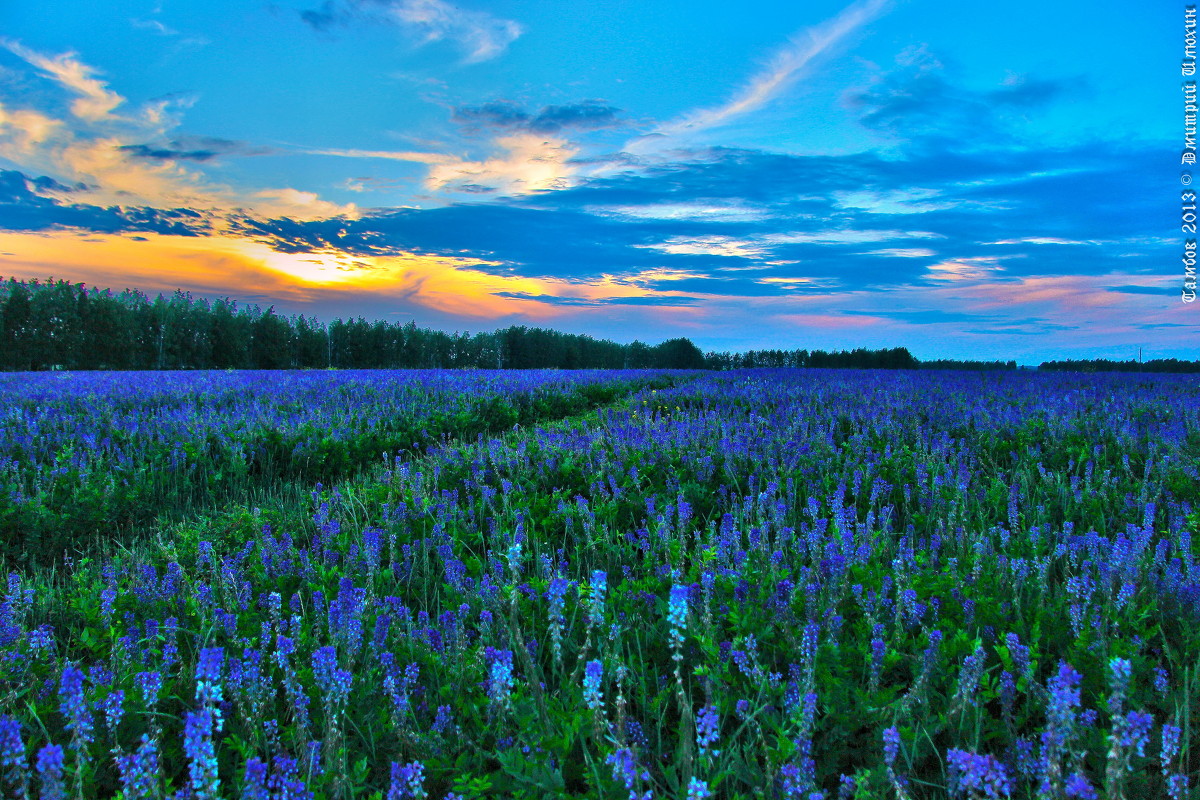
left=0, top=231, right=696, bottom=320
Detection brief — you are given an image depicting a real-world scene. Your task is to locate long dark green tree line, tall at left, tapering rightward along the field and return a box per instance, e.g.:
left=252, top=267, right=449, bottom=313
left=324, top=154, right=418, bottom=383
left=0, top=278, right=1032, bottom=372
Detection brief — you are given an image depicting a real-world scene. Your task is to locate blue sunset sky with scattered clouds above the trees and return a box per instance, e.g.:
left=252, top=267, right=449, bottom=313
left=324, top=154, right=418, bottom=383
left=0, top=0, right=1180, bottom=363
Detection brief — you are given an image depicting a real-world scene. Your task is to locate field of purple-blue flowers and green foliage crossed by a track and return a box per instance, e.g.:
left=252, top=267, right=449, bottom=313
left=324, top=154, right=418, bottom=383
left=0, top=369, right=1200, bottom=800
